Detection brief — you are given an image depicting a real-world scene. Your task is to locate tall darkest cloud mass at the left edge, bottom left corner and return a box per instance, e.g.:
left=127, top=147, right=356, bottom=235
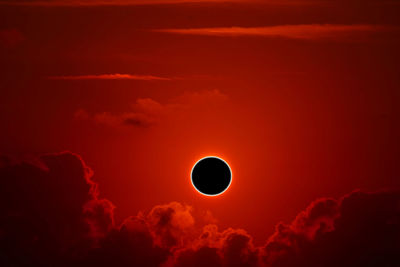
left=0, top=152, right=113, bottom=266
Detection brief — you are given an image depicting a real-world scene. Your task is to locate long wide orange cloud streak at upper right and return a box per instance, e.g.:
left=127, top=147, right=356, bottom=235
left=155, top=24, right=387, bottom=40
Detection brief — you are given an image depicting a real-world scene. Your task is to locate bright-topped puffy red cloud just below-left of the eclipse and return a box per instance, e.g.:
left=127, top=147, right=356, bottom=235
left=79, top=202, right=194, bottom=266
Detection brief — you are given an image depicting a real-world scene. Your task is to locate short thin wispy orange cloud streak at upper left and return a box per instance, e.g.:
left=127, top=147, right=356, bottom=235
left=48, top=73, right=172, bottom=81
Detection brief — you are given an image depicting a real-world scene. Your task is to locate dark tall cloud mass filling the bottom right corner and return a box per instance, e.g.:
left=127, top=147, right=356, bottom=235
left=263, top=191, right=400, bottom=267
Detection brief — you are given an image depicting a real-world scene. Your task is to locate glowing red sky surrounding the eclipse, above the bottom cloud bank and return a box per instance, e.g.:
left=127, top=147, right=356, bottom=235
left=0, top=0, right=400, bottom=266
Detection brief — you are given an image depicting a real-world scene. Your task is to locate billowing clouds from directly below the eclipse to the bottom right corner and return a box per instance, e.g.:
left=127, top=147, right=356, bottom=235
left=168, top=190, right=400, bottom=267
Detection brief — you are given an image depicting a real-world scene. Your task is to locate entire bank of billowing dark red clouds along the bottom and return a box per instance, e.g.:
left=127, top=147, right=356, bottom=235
left=0, top=152, right=400, bottom=267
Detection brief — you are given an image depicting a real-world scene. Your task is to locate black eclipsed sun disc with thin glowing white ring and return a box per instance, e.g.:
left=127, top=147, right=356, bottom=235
left=191, top=157, right=232, bottom=196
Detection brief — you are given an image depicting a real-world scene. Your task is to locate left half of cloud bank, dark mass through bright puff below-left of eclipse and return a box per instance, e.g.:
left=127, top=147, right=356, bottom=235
left=0, top=152, right=198, bottom=266
